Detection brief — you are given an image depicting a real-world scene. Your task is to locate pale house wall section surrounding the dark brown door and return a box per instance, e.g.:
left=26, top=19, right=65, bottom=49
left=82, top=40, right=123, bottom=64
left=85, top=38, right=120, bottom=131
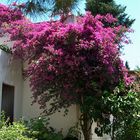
left=0, top=50, right=22, bottom=119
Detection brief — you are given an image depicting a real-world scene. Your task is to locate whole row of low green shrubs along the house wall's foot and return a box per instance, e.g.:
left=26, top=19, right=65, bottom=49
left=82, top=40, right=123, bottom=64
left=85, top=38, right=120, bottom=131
left=0, top=113, right=78, bottom=140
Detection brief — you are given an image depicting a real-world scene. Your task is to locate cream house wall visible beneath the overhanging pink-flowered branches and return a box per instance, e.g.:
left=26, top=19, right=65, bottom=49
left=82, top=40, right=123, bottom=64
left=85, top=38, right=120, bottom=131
left=23, top=80, right=77, bottom=135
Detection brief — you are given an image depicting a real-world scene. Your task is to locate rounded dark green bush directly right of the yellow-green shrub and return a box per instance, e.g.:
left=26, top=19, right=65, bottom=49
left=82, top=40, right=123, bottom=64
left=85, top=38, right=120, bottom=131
left=26, top=117, right=63, bottom=140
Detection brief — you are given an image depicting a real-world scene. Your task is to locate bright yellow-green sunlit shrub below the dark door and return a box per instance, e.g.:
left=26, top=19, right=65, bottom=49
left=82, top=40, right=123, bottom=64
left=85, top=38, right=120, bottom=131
left=0, top=113, right=33, bottom=140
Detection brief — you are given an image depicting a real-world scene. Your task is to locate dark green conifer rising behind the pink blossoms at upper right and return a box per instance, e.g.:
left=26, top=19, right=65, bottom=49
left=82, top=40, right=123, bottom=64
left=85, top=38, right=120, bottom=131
left=86, top=0, right=135, bottom=27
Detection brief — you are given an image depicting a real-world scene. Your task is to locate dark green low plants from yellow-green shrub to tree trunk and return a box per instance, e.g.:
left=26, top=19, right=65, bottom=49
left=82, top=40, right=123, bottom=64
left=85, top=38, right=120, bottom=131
left=25, top=117, right=80, bottom=140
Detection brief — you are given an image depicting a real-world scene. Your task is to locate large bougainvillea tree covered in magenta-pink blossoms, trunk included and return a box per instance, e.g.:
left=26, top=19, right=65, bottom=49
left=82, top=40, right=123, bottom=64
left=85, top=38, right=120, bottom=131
left=0, top=5, right=136, bottom=140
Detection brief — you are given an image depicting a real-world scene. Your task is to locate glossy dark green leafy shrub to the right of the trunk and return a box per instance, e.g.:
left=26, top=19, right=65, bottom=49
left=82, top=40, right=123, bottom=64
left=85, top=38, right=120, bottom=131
left=95, top=84, right=140, bottom=140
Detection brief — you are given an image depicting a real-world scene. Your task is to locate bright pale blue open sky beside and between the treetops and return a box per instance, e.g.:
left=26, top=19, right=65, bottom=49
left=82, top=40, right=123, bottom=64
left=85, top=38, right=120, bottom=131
left=0, top=0, right=140, bottom=69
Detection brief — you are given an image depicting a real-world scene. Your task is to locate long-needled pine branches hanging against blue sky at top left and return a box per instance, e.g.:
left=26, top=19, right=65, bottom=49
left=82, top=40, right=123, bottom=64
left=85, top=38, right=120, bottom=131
left=8, top=0, right=79, bottom=16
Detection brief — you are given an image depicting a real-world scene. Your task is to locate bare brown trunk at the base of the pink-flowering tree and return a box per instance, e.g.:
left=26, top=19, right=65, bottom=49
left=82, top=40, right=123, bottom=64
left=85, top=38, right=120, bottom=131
left=80, top=113, right=93, bottom=140
